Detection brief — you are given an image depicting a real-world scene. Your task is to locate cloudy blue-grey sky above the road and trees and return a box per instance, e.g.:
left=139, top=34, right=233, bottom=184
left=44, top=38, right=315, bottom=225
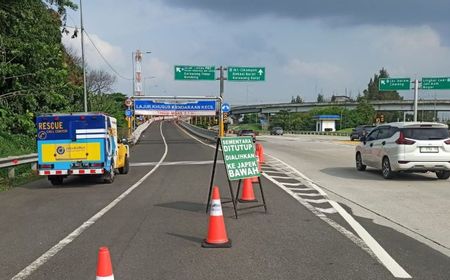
left=63, top=0, right=450, bottom=105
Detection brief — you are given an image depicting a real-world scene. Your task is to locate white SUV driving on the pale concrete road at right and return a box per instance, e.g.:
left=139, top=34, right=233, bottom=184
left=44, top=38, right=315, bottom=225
left=355, top=122, right=450, bottom=179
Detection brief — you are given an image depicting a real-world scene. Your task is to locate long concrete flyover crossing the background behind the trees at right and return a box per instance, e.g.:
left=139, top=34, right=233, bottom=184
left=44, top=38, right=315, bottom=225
left=230, top=100, right=450, bottom=115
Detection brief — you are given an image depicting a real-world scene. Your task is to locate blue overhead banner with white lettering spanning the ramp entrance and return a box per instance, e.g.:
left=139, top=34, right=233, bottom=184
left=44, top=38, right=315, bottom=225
left=134, top=100, right=216, bottom=116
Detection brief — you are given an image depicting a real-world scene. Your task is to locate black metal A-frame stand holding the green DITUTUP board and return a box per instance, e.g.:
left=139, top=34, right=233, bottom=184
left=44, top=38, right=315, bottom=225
left=206, top=137, right=267, bottom=219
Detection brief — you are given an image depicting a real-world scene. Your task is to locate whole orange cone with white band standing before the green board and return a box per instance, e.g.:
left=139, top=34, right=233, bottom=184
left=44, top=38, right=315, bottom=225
left=202, top=186, right=231, bottom=248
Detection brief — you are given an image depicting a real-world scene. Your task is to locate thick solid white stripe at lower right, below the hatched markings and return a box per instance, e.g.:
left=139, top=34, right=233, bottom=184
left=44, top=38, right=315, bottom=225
left=329, top=200, right=411, bottom=278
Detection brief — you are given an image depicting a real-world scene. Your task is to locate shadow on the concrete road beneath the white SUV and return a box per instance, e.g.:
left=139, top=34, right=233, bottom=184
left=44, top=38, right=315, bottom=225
left=320, top=167, right=437, bottom=181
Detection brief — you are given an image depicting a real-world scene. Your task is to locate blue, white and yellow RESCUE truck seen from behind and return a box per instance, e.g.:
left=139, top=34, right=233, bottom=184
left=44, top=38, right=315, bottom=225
left=36, top=113, right=130, bottom=185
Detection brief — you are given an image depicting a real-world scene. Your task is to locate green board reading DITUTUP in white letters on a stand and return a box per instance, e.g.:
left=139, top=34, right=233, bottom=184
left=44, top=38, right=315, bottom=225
left=220, top=136, right=260, bottom=181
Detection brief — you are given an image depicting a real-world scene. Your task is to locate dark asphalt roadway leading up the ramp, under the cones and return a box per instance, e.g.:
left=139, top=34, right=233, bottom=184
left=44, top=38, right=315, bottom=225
left=0, top=122, right=450, bottom=279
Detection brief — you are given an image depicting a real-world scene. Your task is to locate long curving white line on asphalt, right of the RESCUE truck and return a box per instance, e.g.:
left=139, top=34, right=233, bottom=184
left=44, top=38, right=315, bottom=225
left=11, top=122, right=168, bottom=280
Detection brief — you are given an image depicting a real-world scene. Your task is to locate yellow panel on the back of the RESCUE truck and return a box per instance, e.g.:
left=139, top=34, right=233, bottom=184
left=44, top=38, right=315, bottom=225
left=41, top=143, right=101, bottom=162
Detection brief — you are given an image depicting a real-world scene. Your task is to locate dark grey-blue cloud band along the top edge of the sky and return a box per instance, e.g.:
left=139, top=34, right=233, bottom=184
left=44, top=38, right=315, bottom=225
left=164, top=0, right=450, bottom=26
